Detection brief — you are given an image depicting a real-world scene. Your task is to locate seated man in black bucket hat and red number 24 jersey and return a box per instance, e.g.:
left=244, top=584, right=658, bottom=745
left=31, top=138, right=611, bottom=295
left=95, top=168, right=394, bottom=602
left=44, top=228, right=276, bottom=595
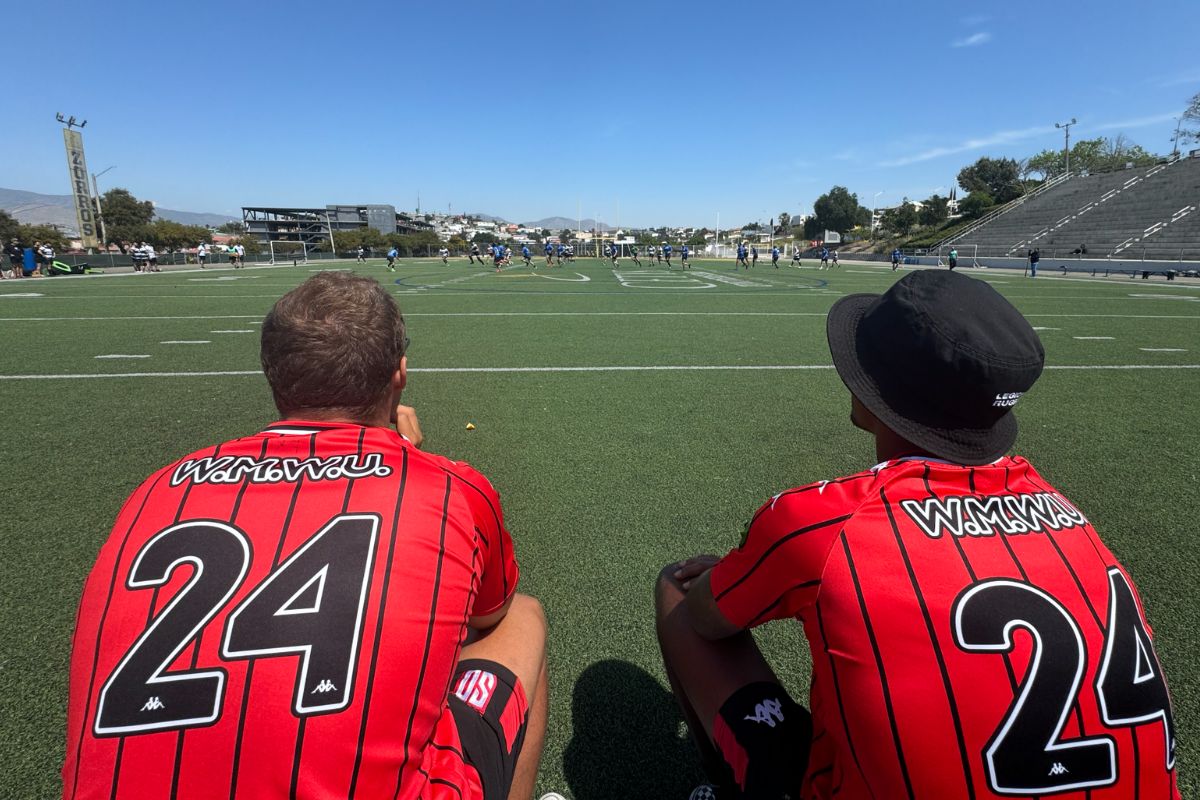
left=656, top=271, right=1180, bottom=800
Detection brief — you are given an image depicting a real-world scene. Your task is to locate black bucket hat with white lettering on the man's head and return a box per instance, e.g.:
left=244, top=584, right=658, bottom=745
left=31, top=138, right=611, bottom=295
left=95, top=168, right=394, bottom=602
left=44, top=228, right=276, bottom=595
left=826, top=270, right=1045, bottom=464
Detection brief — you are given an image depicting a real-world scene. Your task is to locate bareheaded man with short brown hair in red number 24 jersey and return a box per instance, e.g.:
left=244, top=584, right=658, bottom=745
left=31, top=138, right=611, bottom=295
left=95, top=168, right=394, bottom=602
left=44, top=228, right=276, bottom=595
left=62, top=272, right=547, bottom=800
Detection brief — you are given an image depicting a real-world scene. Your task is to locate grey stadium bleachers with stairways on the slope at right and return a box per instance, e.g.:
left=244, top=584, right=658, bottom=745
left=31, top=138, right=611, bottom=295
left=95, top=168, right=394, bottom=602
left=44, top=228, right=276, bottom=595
left=947, top=151, right=1200, bottom=261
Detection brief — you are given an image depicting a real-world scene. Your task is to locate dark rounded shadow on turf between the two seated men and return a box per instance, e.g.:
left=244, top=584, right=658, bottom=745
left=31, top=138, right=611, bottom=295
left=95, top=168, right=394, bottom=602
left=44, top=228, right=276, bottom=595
left=563, top=660, right=702, bottom=800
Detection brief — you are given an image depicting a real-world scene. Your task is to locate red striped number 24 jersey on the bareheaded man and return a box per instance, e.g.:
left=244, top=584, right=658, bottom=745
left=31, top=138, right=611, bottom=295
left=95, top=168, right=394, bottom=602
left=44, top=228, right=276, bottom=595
left=62, top=421, right=517, bottom=800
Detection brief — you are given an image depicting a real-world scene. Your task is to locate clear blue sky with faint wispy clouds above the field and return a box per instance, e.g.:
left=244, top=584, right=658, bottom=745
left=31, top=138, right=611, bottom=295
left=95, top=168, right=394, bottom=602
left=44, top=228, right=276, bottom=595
left=0, top=0, right=1200, bottom=227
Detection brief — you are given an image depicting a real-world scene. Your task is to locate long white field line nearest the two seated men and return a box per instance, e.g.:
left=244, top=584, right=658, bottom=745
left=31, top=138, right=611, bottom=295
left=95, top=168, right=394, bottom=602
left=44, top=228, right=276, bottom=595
left=0, top=363, right=1200, bottom=380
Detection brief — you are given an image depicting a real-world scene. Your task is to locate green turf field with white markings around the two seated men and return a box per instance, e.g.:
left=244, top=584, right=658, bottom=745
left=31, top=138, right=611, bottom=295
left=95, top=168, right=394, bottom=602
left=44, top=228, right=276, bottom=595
left=0, top=260, right=1200, bottom=800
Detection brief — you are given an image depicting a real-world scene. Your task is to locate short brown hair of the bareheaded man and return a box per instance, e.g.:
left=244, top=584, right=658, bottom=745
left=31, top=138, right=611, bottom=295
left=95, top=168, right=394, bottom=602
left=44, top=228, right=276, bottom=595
left=260, top=272, right=406, bottom=420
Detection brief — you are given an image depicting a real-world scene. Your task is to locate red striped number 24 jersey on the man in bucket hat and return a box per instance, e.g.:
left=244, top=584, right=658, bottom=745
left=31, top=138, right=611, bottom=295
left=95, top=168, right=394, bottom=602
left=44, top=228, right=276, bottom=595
left=712, top=458, right=1180, bottom=800
